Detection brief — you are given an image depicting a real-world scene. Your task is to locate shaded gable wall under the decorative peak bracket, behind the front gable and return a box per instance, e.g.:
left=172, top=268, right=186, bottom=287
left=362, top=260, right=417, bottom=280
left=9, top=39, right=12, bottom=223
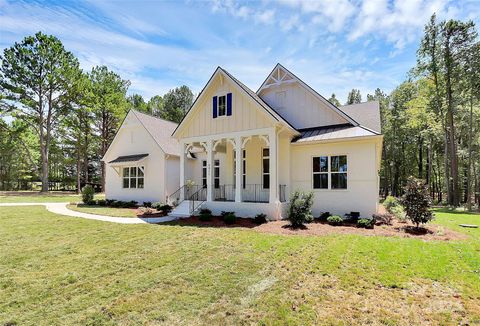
left=260, top=82, right=348, bottom=129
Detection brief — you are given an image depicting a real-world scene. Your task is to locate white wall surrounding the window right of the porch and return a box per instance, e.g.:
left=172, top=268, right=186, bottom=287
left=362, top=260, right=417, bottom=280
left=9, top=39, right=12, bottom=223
left=291, top=140, right=378, bottom=216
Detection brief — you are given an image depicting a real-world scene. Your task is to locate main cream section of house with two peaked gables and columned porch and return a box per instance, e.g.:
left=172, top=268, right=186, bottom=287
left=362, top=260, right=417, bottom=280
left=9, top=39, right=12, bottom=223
left=171, top=64, right=382, bottom=219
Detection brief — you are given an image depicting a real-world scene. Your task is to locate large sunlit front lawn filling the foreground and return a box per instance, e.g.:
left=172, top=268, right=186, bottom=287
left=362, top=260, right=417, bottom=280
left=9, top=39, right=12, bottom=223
left=0, top=207, right=480, bottom=325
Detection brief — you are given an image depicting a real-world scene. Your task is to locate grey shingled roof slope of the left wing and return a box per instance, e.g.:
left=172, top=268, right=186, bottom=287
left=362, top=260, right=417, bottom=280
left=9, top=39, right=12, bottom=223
left=131, top=110, right=180, bottom=156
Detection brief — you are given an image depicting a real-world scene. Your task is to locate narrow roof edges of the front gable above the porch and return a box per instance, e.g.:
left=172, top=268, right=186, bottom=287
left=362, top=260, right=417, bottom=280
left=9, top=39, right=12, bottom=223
left=172, top=66, right=297, bottom=136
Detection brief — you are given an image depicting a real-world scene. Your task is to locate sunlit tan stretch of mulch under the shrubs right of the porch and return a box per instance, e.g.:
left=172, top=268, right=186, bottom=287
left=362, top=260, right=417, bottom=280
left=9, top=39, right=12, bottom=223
left=255, top=221, right=468, bottom=241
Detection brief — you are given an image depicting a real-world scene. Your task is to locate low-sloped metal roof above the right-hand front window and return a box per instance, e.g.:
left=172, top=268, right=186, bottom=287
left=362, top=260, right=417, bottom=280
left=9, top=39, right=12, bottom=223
left=293, top=123, right=380, bottom=143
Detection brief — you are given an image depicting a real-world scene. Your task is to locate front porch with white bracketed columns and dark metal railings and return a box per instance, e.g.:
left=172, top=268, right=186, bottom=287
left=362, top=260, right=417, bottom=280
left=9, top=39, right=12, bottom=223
left=176, top=128, right=288, bottom=217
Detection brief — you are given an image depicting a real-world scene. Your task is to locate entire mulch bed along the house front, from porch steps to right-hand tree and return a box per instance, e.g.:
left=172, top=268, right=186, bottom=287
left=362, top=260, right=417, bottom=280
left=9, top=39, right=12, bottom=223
left=171, top=216, right=468, bottom=241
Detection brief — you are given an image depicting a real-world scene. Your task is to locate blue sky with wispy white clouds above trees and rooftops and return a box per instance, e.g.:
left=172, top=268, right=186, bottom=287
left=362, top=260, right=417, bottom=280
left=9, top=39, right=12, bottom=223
left=0, top=0, right=480, bottom=103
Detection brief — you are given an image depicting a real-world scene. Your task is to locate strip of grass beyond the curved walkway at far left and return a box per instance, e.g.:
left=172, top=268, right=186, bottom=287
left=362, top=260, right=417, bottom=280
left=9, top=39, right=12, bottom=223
left=0, top=191, right=105, bottom=203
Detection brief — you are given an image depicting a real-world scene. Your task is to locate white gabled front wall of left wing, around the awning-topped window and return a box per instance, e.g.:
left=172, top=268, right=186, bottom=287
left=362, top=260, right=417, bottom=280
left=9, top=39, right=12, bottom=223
left=104, top=114, right=179, bottom=203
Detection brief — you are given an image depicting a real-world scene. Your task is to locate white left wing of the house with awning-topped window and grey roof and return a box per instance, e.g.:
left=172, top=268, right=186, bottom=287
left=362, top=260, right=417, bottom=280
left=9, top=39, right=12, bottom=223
left=102, top=110, right=180, bottom=203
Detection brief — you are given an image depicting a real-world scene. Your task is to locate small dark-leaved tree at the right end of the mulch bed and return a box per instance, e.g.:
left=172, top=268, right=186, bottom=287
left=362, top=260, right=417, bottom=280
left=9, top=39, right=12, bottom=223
left=402, top=177, right=433, bottom=228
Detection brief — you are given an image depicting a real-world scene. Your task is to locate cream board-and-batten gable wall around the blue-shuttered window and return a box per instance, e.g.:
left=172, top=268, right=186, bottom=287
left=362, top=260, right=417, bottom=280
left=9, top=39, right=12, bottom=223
left=179, top=75, right=273, bottom=138
